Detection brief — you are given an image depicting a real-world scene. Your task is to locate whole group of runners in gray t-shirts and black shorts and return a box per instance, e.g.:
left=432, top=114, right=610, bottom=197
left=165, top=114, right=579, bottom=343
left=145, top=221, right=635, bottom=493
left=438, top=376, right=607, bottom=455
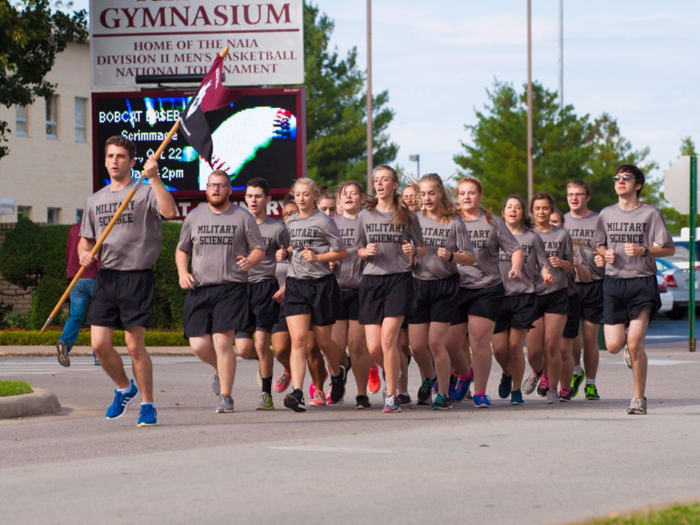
left=68, top=136, right=675, bottom=426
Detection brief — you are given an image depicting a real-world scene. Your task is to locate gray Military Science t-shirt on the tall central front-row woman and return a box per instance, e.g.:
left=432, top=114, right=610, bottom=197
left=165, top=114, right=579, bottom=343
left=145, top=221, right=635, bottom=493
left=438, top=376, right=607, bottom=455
left=355, top=209, right=424, bottom=275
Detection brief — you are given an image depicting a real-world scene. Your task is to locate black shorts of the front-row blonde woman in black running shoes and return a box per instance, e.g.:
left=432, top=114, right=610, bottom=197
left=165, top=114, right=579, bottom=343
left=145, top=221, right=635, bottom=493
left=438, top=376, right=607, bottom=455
left=284, top=273, right=340, bottom=326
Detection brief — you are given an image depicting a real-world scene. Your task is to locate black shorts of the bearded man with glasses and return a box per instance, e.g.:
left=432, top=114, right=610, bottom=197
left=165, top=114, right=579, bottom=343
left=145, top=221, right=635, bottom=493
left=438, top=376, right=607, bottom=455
left=183, top=283, right=250, bottom=337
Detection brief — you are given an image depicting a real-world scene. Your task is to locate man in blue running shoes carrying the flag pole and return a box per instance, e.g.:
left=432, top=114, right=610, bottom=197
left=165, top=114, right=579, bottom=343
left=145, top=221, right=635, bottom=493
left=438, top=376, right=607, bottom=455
left=78, top=135, right=177, bottom=426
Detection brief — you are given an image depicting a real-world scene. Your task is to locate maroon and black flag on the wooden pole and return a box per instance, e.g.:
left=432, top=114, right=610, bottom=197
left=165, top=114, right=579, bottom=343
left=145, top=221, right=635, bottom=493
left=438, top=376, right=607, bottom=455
left=180, top=55, right=240, bottom=164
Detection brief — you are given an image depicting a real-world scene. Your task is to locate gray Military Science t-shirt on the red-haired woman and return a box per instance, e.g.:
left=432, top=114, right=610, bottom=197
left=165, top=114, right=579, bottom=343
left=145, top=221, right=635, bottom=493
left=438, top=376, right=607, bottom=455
left=459, top=210, right=520, bottom=290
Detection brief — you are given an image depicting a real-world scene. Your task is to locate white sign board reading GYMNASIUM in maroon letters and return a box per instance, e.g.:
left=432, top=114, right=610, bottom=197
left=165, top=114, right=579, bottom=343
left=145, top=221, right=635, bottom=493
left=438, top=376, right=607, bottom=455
left=90, top=0, right=304, bottom=88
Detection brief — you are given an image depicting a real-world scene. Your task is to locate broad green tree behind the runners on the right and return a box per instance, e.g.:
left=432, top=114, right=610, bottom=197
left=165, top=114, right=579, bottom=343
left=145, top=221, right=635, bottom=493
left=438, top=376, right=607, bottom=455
left=454, top=80, right=658, bottom=211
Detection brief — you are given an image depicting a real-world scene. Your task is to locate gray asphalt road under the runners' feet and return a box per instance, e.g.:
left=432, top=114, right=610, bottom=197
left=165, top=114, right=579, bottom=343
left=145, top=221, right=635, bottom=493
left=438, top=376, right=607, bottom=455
left=0, top=322, right=700, bottom=525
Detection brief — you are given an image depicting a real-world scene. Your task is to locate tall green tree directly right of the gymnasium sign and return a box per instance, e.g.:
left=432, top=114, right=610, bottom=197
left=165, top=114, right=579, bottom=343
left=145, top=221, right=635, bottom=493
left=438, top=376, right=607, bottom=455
left=304, top=2, right=399, bottom=186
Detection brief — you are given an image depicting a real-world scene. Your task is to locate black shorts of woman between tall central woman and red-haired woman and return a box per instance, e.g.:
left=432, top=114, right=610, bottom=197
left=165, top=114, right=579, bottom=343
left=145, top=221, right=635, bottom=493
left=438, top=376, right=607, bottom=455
left=408, top=274, right=459, bottom=324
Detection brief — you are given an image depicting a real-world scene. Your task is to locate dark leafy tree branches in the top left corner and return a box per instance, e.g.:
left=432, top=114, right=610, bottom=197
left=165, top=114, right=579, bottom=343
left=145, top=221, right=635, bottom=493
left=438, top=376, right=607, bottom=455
left=0, top=0, right=88, bottom=159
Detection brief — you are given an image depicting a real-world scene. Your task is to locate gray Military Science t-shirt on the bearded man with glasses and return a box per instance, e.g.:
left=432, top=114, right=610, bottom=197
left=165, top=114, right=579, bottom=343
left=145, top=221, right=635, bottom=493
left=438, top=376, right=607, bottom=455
left=177, top=202, right=265, bottom=287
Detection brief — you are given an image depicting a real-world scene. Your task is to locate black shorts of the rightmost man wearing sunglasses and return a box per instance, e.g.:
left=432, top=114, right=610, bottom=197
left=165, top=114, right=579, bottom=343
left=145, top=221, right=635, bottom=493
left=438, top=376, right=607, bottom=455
left=603, top=275, right=661, bottom=325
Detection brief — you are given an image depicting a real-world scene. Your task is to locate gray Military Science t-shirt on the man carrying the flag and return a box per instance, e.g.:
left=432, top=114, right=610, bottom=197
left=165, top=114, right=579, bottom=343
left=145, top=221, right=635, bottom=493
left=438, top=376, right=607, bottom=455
left=80, top=184, right=163, bottom=271
